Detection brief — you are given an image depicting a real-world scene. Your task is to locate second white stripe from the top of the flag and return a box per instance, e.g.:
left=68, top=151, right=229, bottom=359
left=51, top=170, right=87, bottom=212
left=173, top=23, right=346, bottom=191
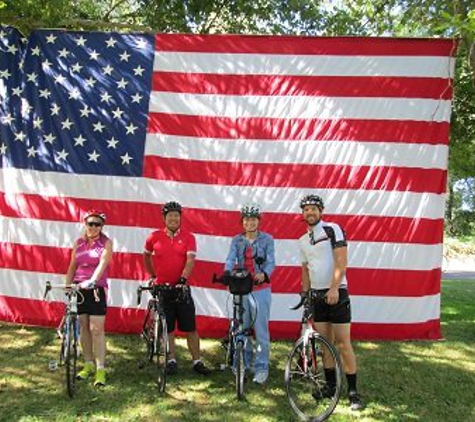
left=149, top=91, right=451, bottom=122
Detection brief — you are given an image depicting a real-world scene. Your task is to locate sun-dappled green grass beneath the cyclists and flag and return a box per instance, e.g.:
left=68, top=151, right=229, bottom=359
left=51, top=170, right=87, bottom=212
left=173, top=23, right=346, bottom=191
left=0, top=280, right=475, bottom=422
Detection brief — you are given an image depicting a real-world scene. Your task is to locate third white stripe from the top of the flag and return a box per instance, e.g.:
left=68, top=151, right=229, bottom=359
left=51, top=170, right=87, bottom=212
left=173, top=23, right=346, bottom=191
left=145, top=134, right=448, bottom=170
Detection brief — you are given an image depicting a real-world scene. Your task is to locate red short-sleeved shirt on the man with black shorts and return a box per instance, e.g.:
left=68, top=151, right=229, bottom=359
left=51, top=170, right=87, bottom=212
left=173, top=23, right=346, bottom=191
left=145, top=229, right=196, bottom=284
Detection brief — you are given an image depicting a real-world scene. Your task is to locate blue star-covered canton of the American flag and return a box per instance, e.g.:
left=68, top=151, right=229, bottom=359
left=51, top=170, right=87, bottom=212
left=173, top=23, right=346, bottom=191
left=0, top=27, right=154, bottom=176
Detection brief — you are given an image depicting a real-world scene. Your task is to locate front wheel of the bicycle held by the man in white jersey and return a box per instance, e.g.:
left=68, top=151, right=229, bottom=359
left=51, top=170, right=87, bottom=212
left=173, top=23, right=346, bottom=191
left=284, top=333, right=343, bottom=422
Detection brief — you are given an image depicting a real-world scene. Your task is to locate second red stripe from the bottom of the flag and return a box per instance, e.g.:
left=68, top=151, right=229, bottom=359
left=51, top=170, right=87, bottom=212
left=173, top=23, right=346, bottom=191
left=0, top=243, right=441, bottom=297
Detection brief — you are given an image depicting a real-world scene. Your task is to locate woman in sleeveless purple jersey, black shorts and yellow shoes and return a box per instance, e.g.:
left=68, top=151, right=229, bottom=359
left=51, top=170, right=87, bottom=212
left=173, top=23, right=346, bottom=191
left=66, top=210, right=112, bottom=386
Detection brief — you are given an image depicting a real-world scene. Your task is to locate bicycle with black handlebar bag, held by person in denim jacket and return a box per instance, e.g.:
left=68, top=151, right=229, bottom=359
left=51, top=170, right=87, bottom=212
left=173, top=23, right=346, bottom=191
left=212, top=270, right=269, bottom=400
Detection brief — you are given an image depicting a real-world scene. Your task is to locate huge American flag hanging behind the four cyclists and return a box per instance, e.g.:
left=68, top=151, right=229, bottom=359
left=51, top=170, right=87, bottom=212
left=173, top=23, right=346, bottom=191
left=0, top=27, right=456, bottom=339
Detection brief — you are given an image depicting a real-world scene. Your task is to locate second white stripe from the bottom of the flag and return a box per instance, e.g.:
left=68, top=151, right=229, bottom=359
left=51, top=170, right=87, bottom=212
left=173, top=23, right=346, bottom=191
left=0, top=216, right=442, bottom=270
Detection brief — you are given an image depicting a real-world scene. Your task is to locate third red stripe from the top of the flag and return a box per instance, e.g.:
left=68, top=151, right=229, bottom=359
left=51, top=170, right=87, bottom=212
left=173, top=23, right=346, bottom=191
left=148, top=113, right=450, bottom=145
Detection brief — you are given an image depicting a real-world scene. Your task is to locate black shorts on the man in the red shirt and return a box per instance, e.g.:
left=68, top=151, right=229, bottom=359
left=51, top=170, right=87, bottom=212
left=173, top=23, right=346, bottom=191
left=164, top=293, right=196, bottom=333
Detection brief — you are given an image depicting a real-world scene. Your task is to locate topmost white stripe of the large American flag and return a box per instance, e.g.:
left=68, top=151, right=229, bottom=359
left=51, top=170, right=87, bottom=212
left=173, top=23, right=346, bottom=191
left=153, top=51, right=455, bottom=78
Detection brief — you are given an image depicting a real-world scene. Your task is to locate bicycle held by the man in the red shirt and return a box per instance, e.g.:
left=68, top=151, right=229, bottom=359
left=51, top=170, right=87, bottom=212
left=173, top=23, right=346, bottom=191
left=137, top=282, right=178, bottom=393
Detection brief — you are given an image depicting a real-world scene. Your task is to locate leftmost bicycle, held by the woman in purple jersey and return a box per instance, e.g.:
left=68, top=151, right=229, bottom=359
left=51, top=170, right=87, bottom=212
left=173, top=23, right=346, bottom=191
left=43, top=281, right=84, bottom=397
